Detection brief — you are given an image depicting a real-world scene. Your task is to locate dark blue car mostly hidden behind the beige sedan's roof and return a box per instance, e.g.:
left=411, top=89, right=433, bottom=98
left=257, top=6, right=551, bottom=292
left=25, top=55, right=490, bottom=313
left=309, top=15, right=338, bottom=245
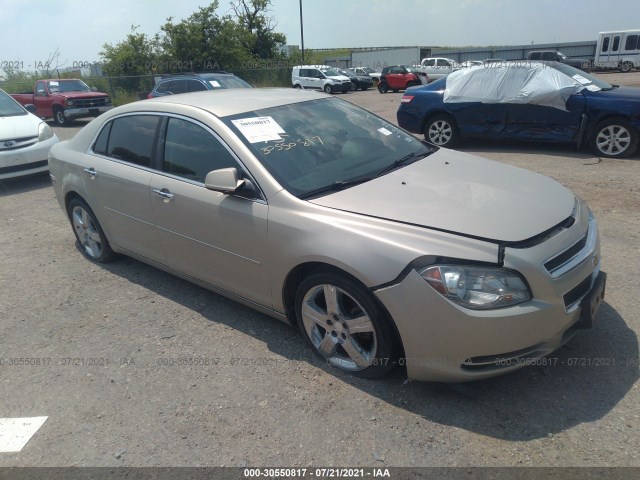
left=148, top=72, right=253, bottom=98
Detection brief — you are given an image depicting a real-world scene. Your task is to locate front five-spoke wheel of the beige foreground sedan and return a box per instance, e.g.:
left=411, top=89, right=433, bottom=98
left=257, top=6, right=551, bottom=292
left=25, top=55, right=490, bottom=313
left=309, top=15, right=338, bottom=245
left=295, top=271, right=397, bottom=378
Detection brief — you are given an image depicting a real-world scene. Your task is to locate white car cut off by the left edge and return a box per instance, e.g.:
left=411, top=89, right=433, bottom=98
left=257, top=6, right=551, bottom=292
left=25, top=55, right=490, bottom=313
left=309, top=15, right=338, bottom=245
left=0, top=90, right=58, bottom=180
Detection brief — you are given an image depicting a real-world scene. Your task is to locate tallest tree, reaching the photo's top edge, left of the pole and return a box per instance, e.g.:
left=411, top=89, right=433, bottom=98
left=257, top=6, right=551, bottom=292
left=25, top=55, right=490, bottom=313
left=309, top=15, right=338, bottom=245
left=231, top=0, right=287, bottom=59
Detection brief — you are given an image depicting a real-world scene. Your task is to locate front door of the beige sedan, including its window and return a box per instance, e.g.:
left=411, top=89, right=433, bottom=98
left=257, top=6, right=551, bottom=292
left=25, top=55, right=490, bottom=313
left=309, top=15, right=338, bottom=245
left=150, top=116, right=271, bottom=307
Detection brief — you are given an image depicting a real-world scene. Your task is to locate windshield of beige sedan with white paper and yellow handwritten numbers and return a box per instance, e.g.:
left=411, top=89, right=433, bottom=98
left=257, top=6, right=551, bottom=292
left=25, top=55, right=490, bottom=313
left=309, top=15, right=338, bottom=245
left=223, top=98, right=433, bottom=197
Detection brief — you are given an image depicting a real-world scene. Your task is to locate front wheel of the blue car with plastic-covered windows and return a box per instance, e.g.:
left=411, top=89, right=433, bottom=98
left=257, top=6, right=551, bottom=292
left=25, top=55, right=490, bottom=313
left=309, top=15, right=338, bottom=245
left=591, top=118, right=638, bottom=158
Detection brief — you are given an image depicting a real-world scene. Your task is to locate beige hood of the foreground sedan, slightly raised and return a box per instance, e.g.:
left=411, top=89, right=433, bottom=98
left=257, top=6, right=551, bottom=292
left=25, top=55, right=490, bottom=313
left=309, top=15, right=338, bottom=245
left=310, top=149, right=575, bottom=242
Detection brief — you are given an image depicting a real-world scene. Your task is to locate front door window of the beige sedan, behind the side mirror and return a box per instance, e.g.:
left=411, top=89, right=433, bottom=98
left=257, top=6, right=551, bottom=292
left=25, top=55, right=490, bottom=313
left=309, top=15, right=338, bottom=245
left=163, top=118, right=239, bottom=183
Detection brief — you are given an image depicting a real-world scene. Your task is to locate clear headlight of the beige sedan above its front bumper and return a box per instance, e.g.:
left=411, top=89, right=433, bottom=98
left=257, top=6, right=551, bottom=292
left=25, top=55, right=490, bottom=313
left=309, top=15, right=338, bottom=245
left=418, top=265, right=531, bottom=310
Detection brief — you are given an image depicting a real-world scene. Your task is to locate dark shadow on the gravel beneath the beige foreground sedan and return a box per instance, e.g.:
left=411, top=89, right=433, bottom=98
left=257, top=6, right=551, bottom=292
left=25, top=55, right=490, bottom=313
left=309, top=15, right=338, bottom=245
left=97, top=257, right=640, bottom=440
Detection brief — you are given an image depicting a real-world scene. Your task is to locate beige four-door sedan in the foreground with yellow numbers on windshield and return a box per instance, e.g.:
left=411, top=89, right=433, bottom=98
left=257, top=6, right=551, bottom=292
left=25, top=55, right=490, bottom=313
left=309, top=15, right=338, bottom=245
left=49, top=89, right=605, bottom=381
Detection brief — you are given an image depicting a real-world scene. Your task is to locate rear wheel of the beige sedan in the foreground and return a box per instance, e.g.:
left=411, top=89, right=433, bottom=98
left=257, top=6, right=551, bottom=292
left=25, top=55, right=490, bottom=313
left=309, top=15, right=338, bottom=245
left=67, top=198, right=116, bottom=263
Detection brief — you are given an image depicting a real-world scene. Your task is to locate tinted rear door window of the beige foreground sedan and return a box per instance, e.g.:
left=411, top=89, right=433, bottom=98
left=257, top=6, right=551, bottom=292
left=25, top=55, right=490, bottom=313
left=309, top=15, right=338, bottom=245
left=105, top=115, right=159, bottom=167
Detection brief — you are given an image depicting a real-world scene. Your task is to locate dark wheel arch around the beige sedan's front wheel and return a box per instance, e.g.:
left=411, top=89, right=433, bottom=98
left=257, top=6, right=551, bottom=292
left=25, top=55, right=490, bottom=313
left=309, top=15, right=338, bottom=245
left=282, top=261, right=404, bottom=357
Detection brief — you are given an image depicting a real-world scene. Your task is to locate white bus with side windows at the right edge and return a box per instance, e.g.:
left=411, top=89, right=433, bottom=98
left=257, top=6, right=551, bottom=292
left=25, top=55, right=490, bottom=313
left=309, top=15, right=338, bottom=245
left=593, top=30, right=640, bottom=72
